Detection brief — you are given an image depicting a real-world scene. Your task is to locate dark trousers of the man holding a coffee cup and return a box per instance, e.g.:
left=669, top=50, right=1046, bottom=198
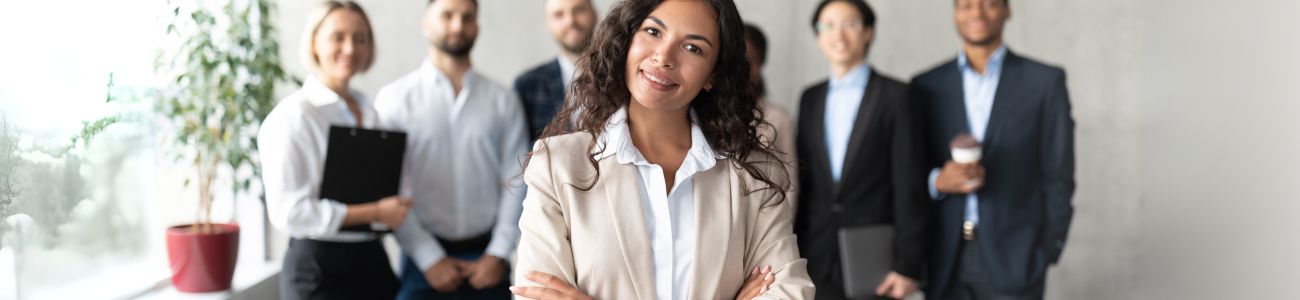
left=939, top=239, right=1043, bottom=300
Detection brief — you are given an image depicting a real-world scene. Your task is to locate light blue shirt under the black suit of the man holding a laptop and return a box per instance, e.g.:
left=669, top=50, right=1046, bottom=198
left=824, top=61, right=871, bottom=183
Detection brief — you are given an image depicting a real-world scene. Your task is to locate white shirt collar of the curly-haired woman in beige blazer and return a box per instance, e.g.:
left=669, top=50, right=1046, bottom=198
left=595, top=107, right=725, bottom=174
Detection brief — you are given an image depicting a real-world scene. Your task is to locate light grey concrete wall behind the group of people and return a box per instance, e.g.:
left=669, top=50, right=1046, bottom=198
left=277, top=0, right=1300, bottom=299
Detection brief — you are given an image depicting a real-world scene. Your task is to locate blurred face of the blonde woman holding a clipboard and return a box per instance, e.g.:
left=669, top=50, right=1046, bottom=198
left=312, top=9, right=371, bottom=81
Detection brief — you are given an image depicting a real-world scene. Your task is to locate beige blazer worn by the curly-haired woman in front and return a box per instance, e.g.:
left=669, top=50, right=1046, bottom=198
left=515, top=132, right=814, bottom=300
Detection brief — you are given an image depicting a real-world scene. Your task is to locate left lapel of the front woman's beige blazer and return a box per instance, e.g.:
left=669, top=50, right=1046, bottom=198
left=601, top=157, right=654, bottom=299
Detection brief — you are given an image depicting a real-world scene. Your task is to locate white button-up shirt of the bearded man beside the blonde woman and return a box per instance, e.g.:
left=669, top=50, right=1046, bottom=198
left=374, top=60, right=529, bottom=270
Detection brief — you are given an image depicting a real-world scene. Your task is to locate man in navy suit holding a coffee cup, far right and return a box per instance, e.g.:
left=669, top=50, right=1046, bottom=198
left=911, top=0, right=1075, bottom=299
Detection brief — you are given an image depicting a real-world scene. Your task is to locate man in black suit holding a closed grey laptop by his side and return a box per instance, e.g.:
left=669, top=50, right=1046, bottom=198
left=794, top=0, right=930, bottom=300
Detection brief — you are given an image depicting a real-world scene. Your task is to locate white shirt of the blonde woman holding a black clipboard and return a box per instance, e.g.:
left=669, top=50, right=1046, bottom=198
left=257, top=77, right=377, bottom=242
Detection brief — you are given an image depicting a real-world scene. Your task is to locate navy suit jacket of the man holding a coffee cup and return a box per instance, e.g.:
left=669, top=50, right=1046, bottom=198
left=911, top=52, right=1074, bottom=295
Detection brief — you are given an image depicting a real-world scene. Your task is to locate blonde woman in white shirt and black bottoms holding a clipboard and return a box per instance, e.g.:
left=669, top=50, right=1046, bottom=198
left=257, top=1, right=411, bottom=299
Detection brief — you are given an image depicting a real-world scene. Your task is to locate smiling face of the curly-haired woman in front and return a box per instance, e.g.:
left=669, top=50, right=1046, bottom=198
left=625, top=0, right=722, bottom=110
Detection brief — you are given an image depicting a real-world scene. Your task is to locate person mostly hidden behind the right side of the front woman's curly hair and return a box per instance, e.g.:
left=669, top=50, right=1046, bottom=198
left=745, top=23, right=798, bottom=208
